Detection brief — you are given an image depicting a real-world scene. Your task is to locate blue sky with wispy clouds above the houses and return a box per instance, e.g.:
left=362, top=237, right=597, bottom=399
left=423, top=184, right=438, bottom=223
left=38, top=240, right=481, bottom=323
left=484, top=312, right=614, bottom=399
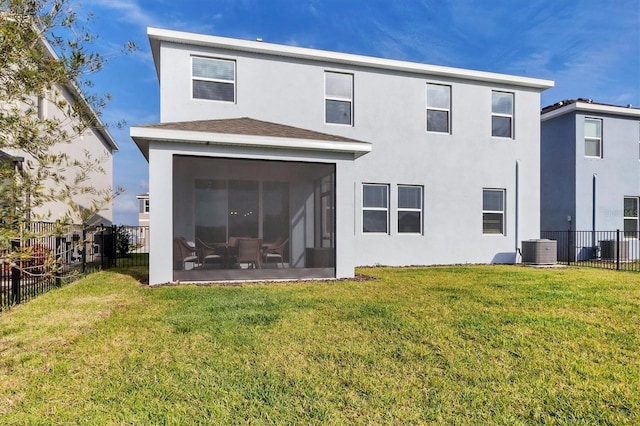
left=79, top=0, right=640, bottom=224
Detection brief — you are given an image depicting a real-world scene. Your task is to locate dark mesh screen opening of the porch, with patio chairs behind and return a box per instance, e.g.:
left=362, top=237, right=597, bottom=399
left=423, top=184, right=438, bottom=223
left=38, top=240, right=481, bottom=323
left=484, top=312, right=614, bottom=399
left=173, top=155, right=335, bottom=281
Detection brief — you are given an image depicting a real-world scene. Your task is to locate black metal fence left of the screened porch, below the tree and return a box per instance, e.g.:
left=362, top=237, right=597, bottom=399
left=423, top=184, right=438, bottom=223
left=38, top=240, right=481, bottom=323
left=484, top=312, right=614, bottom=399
left=0, top=222, right=149, bottom=311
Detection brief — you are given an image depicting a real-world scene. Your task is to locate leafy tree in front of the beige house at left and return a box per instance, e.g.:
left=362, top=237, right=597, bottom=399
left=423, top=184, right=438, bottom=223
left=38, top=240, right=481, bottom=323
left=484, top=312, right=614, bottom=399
left=0, top=0, right=135, bottom=270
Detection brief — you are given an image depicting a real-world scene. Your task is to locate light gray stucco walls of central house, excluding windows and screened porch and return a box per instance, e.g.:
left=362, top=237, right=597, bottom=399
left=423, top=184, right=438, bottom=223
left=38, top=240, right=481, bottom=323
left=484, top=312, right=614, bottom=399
left=134, top=29, right=553, bottom=284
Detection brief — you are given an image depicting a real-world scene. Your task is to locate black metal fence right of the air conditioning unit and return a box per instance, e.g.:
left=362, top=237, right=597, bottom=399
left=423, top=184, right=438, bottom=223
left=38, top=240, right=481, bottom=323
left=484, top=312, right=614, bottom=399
left=540, top=230, right=640, bottom=272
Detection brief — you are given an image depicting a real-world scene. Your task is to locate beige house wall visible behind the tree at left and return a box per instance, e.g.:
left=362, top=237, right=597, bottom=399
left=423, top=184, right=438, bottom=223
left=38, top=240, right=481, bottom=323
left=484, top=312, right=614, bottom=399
left=0, top=32, right=118, bottom=225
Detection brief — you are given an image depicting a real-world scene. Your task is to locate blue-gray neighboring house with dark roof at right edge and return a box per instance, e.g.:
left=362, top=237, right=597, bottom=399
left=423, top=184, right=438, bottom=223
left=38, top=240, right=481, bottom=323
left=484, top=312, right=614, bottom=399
left=540, top=99, right=640, bottom=257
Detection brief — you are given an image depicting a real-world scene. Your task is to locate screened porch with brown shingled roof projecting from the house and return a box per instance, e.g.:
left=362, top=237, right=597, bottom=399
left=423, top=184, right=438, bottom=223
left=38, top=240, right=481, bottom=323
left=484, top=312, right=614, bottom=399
left=131, top=118, right=371, bottom=285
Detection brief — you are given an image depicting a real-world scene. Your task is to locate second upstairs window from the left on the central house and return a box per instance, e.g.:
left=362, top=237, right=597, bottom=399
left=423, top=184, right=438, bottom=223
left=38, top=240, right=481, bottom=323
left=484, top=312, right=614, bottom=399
left=324, top=72, right=353, bottom=126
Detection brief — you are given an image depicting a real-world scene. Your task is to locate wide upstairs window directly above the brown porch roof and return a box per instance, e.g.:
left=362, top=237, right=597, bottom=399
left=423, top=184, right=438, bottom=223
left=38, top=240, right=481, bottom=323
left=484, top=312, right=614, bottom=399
left=191, top=57, right=236, bottom=102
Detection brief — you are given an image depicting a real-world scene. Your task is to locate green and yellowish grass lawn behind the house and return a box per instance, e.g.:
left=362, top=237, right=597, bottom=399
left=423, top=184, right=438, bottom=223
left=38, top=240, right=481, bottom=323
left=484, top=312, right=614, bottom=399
left=0, top=266, right=640, bottom=425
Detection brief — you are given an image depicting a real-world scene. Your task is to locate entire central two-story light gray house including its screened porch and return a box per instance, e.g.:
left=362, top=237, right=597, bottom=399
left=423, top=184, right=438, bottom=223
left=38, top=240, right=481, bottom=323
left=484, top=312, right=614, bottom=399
left=131, top=28, right=553, bottom=284
